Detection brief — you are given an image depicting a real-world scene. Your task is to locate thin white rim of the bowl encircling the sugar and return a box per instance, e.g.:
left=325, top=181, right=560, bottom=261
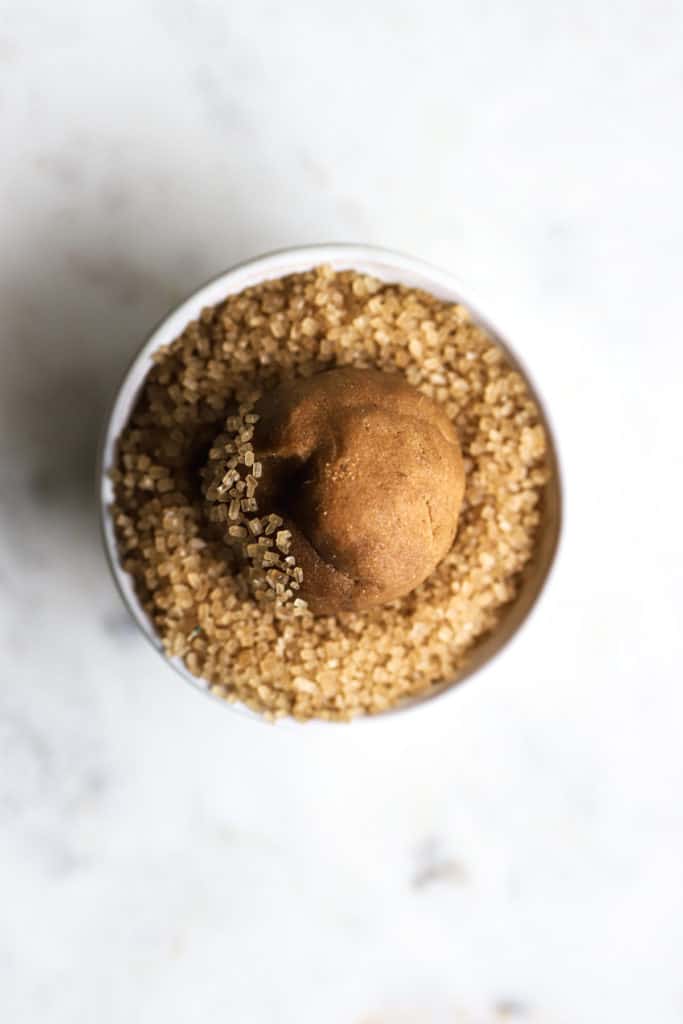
left=97, top=243, right=561, bottom=728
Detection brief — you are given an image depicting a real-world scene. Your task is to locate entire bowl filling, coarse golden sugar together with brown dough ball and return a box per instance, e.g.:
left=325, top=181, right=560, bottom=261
left=114, top=267, right=547, bottom=719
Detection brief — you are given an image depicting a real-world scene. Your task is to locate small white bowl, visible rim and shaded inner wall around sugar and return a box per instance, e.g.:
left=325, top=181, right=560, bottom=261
left=98, top=245, right=561, bottom=724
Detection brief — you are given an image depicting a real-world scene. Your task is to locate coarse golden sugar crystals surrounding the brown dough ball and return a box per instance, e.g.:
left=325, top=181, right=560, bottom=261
left=113, top=267, right=548, bottom=720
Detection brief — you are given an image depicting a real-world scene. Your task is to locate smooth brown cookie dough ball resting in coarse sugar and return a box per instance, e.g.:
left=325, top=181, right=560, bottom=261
left=254, top=369, right=465, bottom=614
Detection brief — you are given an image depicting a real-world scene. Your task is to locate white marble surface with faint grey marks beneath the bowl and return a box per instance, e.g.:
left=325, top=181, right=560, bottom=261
left=0, top=0, right=683, bottom=1024
